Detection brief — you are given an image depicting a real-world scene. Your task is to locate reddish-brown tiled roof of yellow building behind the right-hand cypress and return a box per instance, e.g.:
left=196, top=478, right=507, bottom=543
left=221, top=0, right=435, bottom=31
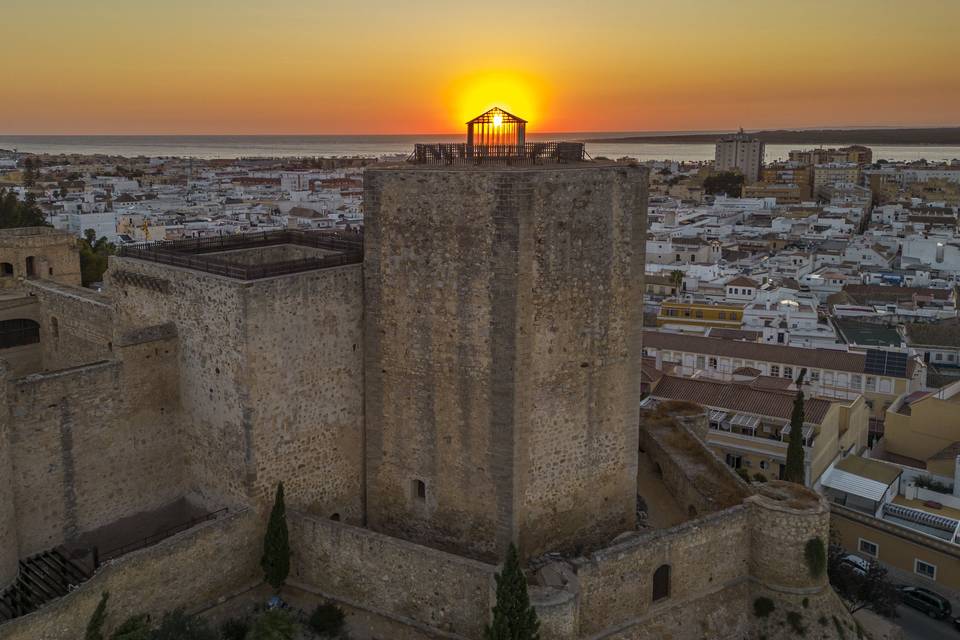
left=650, top=375, right=831, bottom=424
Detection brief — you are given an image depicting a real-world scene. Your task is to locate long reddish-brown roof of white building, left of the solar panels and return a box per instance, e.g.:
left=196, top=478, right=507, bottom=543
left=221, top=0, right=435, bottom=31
left=643, top=331, right=914, bottom=376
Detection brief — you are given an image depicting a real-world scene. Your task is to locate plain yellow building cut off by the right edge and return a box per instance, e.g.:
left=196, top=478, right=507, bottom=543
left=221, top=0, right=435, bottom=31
left=883, top=381, right=960, bottom=470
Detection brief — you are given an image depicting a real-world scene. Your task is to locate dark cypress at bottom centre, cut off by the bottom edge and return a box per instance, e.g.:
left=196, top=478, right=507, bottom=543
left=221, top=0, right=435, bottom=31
left=483, top=544, right=540, bottom=640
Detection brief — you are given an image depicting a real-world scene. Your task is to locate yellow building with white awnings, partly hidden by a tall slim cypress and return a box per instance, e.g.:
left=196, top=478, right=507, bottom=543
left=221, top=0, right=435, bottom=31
left=650, top=375, right=870, bottom=486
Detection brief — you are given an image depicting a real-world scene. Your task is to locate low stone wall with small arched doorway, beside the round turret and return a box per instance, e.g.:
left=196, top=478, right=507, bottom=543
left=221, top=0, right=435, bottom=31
left=575, top=506, right=751, bottom=638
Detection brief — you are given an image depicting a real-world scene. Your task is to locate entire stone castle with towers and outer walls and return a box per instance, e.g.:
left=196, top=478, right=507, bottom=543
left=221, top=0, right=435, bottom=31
left=0, top=122, right=852, bottom=640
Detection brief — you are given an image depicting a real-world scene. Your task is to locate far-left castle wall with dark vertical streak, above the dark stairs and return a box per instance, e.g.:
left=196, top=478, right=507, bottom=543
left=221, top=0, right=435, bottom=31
left=7, top=336, right=184, bottom=557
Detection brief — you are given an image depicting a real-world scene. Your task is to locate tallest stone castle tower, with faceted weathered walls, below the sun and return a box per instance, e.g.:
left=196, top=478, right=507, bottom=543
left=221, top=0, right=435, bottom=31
left=364, top=129, right=647, bottom=560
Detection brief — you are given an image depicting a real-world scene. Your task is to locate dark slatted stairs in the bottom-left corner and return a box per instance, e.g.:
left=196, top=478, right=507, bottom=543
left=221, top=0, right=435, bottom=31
left=0, top=547, right=93, bottom=624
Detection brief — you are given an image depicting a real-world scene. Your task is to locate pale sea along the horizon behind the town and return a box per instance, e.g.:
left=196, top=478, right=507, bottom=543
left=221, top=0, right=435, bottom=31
left=0, top=132, right=960, bottom=162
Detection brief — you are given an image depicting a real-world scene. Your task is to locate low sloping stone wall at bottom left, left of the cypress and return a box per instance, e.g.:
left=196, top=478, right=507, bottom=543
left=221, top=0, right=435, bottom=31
left=0, top=510, right=263, bottom=640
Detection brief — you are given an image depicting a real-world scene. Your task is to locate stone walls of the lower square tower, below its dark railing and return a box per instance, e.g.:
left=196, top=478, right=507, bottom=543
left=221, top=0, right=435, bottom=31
left=107, top=258, right=363, bottom=523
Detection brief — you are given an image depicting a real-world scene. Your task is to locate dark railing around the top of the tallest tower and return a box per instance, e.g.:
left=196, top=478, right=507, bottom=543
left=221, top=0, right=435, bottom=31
left=410, top=142, right=586, bottom=165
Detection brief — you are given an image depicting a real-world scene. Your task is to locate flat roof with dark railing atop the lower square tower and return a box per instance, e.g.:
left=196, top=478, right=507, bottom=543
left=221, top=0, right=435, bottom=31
left=119, top=229, right=363, bottom=280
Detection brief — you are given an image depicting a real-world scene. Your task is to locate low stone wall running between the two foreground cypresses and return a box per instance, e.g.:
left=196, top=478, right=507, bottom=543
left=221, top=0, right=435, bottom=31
left=287, top=512, right=496, bottom=638
